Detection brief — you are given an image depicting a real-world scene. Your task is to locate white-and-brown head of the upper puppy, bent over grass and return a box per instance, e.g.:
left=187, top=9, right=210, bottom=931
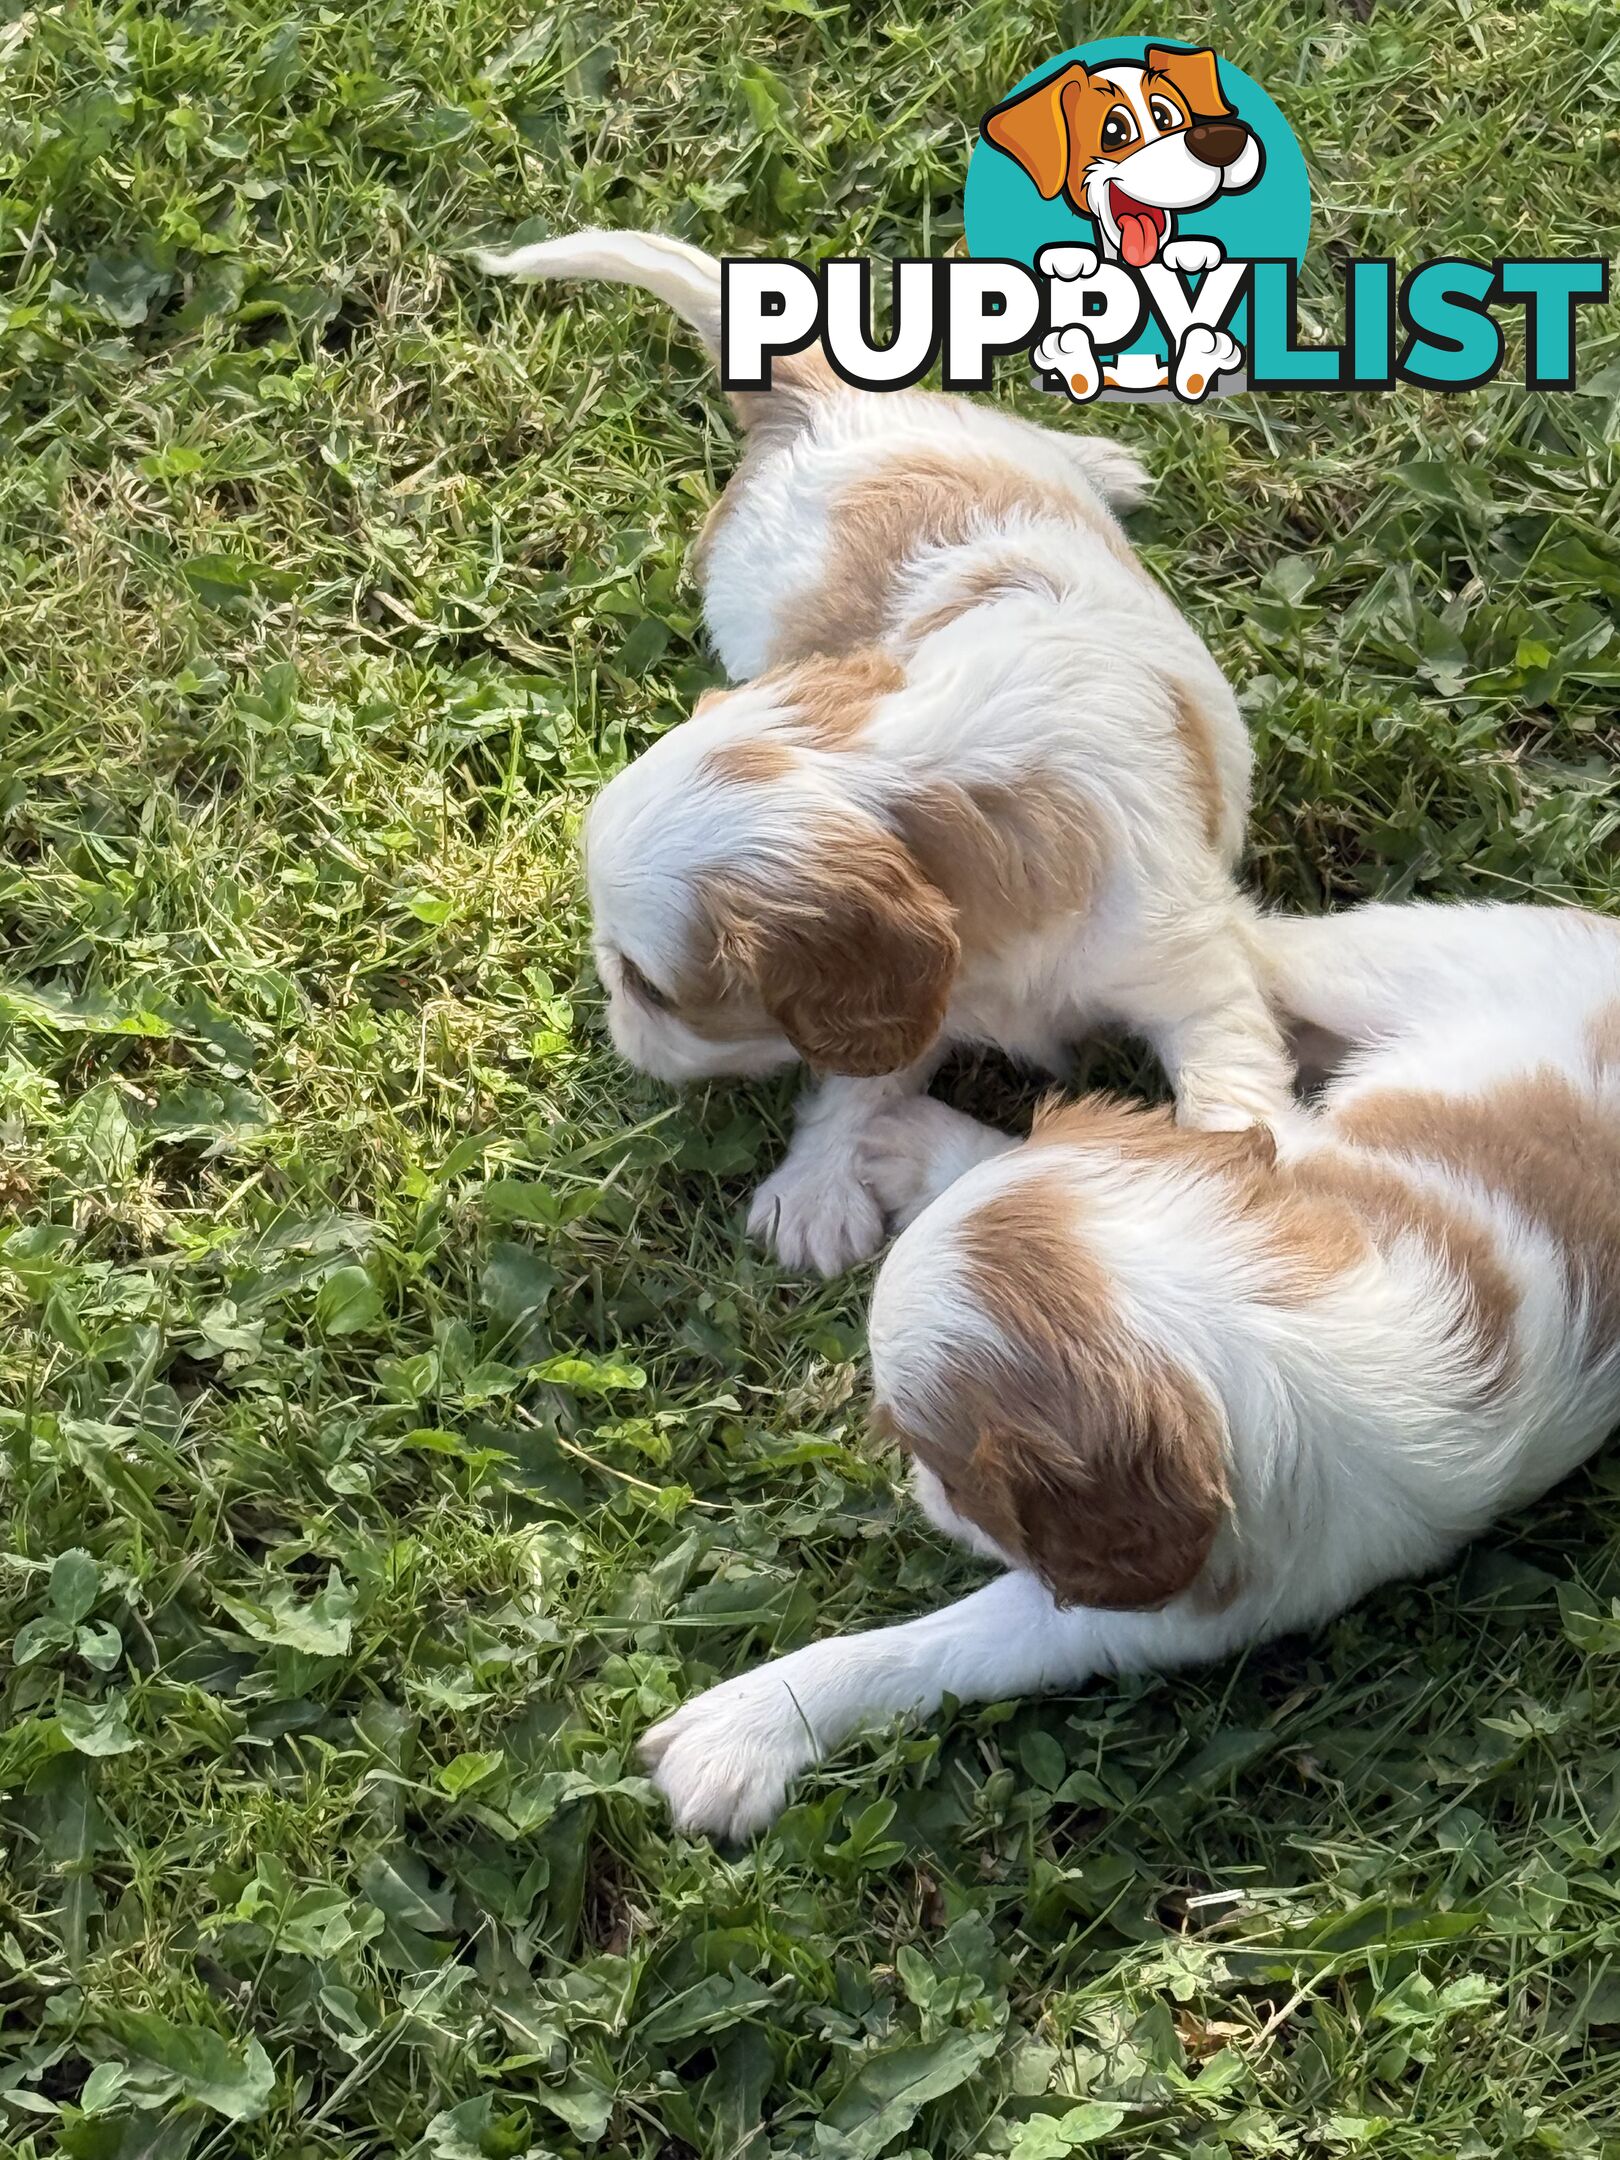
left=585, top=663, right=959, bottom=1080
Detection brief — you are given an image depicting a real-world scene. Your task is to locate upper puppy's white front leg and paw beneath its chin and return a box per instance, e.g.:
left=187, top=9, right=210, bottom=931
left=747, top=1052, right=940, bottom=1274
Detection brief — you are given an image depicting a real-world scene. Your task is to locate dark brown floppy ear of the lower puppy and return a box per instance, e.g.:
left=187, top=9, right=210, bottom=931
left=968, top=1369, right=1231, bottom=1611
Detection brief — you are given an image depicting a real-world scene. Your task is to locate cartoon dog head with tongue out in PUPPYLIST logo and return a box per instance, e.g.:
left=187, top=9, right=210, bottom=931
left=983, top=45, right=1266, bottom=270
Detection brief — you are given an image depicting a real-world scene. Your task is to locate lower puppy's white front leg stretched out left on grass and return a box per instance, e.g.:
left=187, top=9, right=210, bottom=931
left=642, top=1575, right=1240, bottom=1838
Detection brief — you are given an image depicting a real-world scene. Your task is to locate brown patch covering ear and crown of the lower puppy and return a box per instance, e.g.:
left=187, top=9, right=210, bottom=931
left=890, top=1179, right=1231, bottom=1611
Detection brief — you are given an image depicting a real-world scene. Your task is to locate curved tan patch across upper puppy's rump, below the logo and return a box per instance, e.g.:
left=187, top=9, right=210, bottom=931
left=771, top=451, right=1147, bottom=663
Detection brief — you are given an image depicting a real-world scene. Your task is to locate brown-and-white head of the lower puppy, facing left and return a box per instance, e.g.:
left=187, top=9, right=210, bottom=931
left=870, top=1147, right=1231, bottom=1609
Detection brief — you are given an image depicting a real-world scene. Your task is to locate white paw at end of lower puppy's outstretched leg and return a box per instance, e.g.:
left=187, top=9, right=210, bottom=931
left=639, top=1665, right=816, bottom=1840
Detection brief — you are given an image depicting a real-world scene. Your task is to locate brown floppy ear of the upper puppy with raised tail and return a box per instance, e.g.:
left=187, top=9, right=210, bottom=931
left=717, top=825, right=959, bottom=1078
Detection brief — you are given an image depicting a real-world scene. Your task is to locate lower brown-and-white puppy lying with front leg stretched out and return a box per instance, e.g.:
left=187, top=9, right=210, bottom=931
left=646, top=905, right=1620, bottom=1836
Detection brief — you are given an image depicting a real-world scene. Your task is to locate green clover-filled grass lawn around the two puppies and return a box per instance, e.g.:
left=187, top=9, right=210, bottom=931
left=0, top=0, right=1620, bottom=2160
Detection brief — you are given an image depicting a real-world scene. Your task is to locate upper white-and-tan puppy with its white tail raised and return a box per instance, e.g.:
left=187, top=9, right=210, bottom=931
left=486, top=233, right=1290, bottom=1274
